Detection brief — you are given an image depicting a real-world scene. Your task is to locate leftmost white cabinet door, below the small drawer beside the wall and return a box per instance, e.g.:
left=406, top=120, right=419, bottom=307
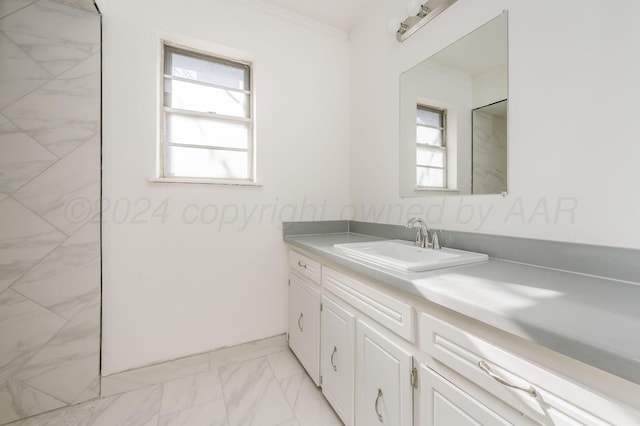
left=289, top=275, right=320, bottom=385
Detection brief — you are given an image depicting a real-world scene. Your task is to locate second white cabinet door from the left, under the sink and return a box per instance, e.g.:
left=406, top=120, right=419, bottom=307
left=320, top=296, right=355, bottom=426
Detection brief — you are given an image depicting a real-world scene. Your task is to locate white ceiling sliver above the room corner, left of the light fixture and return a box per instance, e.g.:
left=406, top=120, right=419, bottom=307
left=260, top=0, right=380, bottom=33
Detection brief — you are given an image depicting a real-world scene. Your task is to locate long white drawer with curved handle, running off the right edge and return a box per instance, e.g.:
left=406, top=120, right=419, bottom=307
left=421, top=313, right=640, bottom=426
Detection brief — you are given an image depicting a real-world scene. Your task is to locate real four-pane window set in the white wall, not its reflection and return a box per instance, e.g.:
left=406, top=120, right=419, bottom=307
left=159, top=43, right=254, bottom=182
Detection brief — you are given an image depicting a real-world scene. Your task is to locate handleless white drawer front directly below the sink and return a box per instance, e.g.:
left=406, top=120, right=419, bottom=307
left=322, top=267, right=414, bottom=342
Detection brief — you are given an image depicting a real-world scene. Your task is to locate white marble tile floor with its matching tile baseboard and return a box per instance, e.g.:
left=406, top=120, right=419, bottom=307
left=10, top=335, right=342, bottom=426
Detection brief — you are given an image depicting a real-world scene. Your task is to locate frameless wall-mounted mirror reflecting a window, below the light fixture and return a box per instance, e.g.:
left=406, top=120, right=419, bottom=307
left=400, top=12, right=508, bottom=197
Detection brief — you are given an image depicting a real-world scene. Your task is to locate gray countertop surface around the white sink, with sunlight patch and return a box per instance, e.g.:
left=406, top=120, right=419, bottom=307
left=285, top=232, right=640, bottom=384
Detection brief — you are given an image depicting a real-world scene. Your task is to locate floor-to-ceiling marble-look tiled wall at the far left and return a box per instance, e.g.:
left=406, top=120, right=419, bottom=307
left=0, top=0, right=100, bottom=424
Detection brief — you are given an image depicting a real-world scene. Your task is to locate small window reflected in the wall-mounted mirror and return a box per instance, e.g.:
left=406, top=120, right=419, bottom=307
left=416, top=104, right=447, bottom=188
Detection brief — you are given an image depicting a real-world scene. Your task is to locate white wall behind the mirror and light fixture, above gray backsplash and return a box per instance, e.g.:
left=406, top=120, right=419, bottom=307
left=345, top=0, right=640, bottom=248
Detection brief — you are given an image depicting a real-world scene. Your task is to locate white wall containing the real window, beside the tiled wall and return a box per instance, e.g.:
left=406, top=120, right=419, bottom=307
left=99, top=0, right=349, bottom=375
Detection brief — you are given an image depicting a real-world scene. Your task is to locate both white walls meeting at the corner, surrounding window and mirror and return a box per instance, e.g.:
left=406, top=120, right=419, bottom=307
left=99, top=0, right=640, bottom=374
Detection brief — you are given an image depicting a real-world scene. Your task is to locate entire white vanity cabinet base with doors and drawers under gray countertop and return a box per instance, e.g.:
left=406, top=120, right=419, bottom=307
left=289, top=246, right=640, bottom=426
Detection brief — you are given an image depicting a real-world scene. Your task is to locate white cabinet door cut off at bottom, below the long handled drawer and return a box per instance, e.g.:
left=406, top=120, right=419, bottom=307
left=420, top=365, right=511, bottom=426
